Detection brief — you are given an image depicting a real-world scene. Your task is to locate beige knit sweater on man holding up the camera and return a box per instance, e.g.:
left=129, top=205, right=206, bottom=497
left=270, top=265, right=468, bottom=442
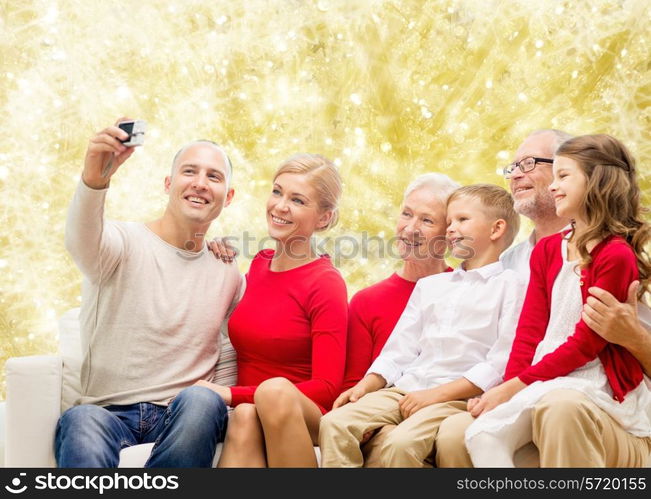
left=66, top=181, right=243, bottom=405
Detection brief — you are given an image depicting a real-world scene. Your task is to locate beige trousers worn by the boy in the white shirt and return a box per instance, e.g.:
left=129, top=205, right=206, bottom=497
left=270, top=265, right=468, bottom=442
left=319, top=388, right=466, bottom=468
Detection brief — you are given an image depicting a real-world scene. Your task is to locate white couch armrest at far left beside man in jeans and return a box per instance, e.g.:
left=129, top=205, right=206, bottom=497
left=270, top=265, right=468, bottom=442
left=5, top=355, right=63, bottom=468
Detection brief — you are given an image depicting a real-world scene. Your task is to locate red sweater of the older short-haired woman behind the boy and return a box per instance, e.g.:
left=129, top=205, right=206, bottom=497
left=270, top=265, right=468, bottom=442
left=343, top=267, right=452, bottom=390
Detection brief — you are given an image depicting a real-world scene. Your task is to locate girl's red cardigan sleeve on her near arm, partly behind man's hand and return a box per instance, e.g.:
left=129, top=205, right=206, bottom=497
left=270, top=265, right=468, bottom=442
left=518, top=243, right=638, bottom=384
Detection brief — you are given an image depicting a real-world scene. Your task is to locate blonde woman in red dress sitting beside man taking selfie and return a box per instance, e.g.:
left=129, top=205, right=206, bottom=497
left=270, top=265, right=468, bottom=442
left=207, top=154, right=348, bottom=467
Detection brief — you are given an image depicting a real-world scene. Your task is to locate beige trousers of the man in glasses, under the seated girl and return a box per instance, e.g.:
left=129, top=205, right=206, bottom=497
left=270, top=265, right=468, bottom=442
left=418, top=390, right=651, bottom=468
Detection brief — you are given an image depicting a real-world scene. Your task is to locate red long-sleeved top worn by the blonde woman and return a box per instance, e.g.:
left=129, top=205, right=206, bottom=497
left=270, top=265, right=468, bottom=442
left=228, top=250, right=348, bottom=413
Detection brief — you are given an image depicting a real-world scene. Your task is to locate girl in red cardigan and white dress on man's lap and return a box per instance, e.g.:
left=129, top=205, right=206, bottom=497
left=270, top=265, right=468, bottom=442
left=466, top=135, right=651, bottom=467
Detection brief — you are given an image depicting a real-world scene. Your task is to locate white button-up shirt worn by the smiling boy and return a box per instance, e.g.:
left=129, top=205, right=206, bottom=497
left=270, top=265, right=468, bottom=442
left=367, top=262, right=525, bottom=392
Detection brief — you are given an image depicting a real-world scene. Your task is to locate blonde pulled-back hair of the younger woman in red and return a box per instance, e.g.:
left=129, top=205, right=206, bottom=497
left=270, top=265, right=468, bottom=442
left=274, top=153, right=342, bottom=231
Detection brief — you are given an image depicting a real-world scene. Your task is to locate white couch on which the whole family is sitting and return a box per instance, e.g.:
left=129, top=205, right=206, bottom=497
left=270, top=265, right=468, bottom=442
left=5, top=308, right=651, bottom=468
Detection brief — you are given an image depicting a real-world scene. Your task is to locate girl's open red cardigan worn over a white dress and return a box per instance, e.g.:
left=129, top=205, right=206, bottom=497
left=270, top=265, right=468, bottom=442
left=504, top=234, right=642, bottom=402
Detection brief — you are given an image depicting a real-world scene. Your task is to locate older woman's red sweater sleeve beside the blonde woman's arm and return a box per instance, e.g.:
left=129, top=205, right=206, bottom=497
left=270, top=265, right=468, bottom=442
left=342, top=294, right=373, bottom=390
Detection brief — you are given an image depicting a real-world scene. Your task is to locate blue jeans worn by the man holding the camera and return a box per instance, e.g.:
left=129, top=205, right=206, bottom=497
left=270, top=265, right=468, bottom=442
left=54, top=386, right=228, bottom=468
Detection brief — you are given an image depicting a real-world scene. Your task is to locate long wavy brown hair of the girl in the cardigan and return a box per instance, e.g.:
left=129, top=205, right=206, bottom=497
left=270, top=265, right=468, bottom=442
left=556, top=134, right=651, bottom=298
